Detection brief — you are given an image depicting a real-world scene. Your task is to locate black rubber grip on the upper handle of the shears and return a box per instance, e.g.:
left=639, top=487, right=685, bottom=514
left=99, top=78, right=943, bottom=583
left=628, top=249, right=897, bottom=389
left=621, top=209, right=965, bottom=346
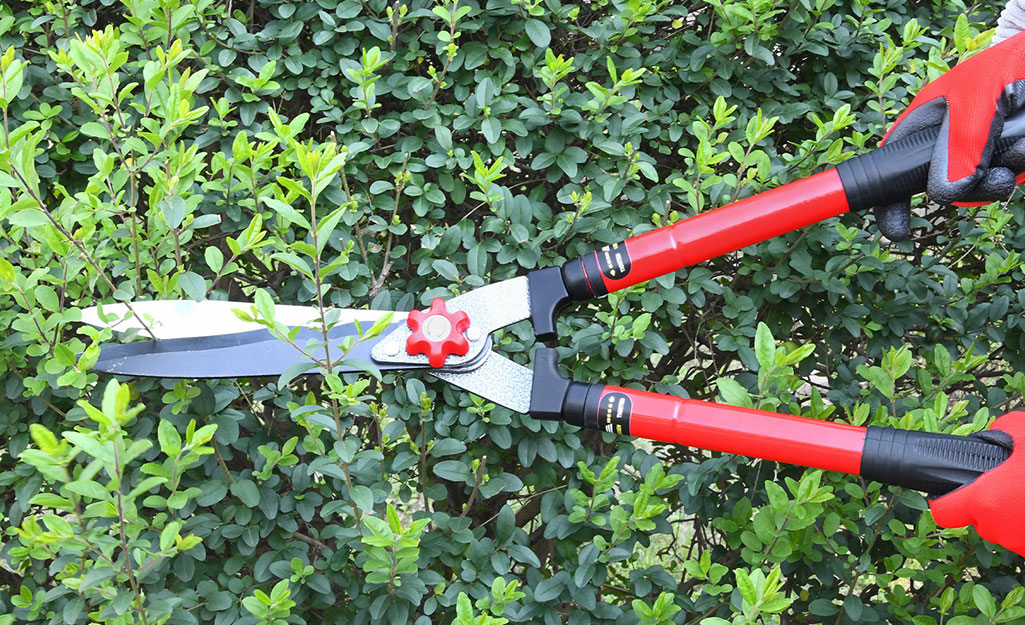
left=836, top=110, right=1025, bottom=211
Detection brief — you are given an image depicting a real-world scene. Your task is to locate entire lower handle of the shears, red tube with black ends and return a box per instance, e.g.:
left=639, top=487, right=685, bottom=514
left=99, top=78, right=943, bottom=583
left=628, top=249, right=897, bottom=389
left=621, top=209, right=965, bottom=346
left=530, top=347, right=1011, bottom=495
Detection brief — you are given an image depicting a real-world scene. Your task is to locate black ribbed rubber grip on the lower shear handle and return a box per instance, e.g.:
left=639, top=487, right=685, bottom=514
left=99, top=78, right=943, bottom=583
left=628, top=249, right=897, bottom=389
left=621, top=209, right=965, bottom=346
left=861, top=426, right=1011, bottom=496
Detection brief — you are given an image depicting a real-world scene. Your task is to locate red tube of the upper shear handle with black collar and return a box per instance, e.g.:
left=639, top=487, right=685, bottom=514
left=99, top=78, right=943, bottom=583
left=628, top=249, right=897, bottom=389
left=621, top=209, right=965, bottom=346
left=563, top=169, right=849, bottom=299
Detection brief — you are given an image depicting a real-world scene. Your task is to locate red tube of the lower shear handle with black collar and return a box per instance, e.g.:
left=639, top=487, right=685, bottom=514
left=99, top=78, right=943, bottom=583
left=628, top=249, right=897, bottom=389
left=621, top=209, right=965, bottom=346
left=584, top=386, right=866, bottom=469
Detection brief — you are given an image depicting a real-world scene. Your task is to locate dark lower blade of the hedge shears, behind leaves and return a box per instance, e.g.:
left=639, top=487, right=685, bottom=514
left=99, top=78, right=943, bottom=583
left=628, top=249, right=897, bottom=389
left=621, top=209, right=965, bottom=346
left=92, top=321, right=417, bottom=379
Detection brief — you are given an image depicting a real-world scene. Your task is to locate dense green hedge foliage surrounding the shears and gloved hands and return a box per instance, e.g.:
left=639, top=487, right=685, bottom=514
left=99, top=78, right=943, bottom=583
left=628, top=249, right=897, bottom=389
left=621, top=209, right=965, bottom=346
left=0, top=0, right=1025, bottom=625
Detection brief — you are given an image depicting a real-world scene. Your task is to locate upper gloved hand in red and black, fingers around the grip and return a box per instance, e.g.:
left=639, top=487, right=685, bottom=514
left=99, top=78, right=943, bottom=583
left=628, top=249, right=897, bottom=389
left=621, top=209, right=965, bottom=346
left=875, top=33, right=1025, bottom=241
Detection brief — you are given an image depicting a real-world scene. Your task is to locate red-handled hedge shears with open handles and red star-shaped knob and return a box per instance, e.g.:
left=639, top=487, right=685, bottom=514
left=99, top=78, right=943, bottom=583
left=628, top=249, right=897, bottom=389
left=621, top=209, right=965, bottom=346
left=83, top=107, right=1025, bottom=495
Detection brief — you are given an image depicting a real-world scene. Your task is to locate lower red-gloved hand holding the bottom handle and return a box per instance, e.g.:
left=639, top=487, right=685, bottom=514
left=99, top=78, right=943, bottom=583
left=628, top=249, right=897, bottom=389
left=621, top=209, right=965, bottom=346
left=929, top=412, right=1025, bottom=555
